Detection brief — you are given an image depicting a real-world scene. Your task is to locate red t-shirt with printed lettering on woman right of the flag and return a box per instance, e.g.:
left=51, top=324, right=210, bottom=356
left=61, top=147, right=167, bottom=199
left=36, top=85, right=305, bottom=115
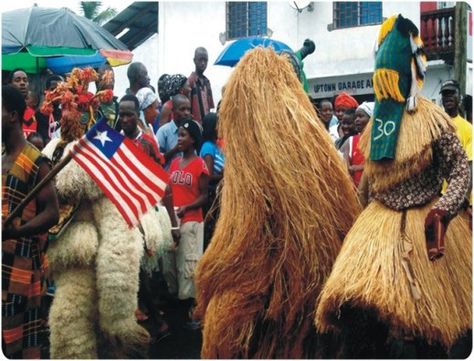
left=169, top=157, right=209, bottom=223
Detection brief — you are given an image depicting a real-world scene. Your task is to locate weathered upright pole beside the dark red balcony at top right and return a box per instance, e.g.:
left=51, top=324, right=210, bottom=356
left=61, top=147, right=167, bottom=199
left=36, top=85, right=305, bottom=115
left=454, top=1, right=467, bottom=96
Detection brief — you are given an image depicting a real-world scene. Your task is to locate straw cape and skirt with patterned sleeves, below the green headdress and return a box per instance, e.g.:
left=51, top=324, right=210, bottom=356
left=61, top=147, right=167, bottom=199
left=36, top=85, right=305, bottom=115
left=316, top=99, right=472, bottom=348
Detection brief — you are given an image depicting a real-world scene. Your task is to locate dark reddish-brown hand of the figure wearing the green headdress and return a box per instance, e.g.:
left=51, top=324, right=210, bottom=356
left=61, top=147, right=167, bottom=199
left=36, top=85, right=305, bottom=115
left=425, top=208, right=448, bottom=261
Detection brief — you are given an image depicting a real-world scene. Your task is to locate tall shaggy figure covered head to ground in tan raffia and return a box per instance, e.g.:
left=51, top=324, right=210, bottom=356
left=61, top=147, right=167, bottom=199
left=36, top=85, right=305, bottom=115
left=195, top=48, right=359, bottom=358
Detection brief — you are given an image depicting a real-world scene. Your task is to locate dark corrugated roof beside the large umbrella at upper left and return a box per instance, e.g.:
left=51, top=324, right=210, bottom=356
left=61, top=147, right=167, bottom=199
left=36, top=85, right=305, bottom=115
left=103, top=1, right=159, bottom=50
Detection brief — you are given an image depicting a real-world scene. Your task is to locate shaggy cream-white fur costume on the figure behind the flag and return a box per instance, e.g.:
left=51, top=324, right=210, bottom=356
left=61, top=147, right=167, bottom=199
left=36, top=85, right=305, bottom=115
left=43, top=139, right=170, bottom=359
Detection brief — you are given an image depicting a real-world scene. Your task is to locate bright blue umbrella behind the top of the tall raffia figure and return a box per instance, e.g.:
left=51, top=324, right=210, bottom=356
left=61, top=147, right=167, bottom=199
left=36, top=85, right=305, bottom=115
left=214, top=36, right=293, bottom=66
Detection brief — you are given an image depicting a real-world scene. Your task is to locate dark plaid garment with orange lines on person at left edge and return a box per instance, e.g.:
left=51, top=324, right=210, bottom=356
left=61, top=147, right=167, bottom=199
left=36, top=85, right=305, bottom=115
left=2, top=143, right=47, bottom=358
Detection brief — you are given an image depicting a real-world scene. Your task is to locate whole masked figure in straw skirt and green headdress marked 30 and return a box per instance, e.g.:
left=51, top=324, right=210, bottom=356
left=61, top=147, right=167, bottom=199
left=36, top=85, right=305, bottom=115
left=315, top=16, right=472, bottom=358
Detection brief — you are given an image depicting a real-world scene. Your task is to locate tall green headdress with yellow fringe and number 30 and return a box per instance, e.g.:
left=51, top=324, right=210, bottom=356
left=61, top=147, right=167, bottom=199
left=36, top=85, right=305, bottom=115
left=370, top=15, right=426, bottom=160
